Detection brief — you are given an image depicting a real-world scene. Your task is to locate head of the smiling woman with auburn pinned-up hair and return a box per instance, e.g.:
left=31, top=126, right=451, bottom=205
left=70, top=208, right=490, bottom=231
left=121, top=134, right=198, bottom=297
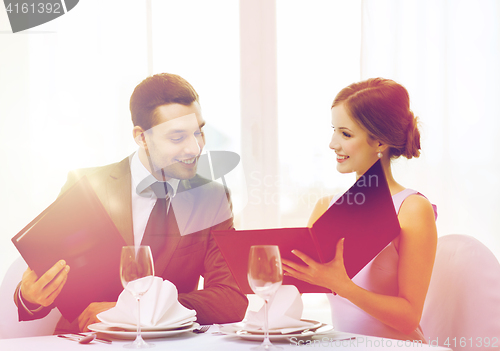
left=330, top=78, right=420, bottom=179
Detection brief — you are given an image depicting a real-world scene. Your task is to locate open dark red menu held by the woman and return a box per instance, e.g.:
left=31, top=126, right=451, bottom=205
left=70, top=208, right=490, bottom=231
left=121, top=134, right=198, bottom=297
left=212, top=160, right=401, bottom=294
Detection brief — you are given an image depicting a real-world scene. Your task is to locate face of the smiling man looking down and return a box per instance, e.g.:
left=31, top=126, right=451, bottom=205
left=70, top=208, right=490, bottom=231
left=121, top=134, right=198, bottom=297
left=134, top=102, right=205, bottom=181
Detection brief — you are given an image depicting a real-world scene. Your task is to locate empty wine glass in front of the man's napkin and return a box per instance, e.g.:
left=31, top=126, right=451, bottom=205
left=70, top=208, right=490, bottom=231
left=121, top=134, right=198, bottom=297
left=120, top=246, right=155, bottom=349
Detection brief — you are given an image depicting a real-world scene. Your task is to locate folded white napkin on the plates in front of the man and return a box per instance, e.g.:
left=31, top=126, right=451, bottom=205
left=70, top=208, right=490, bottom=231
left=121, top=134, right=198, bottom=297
left=97, top=277, right=196, bottom=329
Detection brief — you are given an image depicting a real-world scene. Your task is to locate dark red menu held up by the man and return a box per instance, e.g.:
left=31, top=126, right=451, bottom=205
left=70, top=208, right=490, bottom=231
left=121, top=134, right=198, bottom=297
left=12, top=177, right=126, bottom=321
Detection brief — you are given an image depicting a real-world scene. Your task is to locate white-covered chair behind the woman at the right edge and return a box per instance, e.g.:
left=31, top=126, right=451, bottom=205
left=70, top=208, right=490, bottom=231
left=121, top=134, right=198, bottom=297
left=420, top=234, right=500, bottom=351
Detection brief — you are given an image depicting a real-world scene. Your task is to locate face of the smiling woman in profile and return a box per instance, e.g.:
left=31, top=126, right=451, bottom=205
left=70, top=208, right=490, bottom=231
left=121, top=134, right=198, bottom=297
left=330, top=104, right=381, bottom=178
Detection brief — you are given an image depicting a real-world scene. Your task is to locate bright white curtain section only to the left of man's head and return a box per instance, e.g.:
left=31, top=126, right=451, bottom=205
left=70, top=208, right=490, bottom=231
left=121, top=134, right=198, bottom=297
left=0, top=0, right=147, bottom=277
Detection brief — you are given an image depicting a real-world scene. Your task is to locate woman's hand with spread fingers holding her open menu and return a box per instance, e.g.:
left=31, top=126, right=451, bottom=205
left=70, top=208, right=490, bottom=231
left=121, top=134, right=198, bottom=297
left=283, top=239, right=354, bottom=297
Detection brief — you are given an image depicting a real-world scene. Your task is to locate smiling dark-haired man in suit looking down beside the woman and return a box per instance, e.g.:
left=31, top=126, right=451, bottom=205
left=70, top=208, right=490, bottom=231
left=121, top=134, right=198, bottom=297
left=15, top=73, right=248, bottom=332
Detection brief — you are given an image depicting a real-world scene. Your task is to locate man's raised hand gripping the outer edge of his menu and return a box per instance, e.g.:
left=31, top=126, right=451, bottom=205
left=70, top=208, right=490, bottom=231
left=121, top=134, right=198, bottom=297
left=21, top=260, right=69, bottom=307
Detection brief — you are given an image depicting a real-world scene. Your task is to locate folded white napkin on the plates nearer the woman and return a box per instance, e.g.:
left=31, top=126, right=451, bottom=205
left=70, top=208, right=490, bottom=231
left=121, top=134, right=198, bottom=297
left=244, top=285, right=313, bottom=334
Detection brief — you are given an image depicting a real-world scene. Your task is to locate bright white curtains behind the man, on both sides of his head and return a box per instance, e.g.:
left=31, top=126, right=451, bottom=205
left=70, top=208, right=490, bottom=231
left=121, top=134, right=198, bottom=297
left=0, top=0, right=240, bottom=280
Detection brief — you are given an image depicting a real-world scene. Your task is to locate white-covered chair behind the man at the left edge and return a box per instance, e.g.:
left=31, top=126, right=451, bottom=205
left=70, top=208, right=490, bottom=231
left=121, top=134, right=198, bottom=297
left=0, top=257, right=61, bottom=339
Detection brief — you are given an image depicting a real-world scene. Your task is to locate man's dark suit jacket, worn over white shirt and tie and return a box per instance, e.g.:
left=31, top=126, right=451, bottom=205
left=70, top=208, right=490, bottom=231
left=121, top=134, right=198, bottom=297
left=15, top=158, right=248, bottom=332
